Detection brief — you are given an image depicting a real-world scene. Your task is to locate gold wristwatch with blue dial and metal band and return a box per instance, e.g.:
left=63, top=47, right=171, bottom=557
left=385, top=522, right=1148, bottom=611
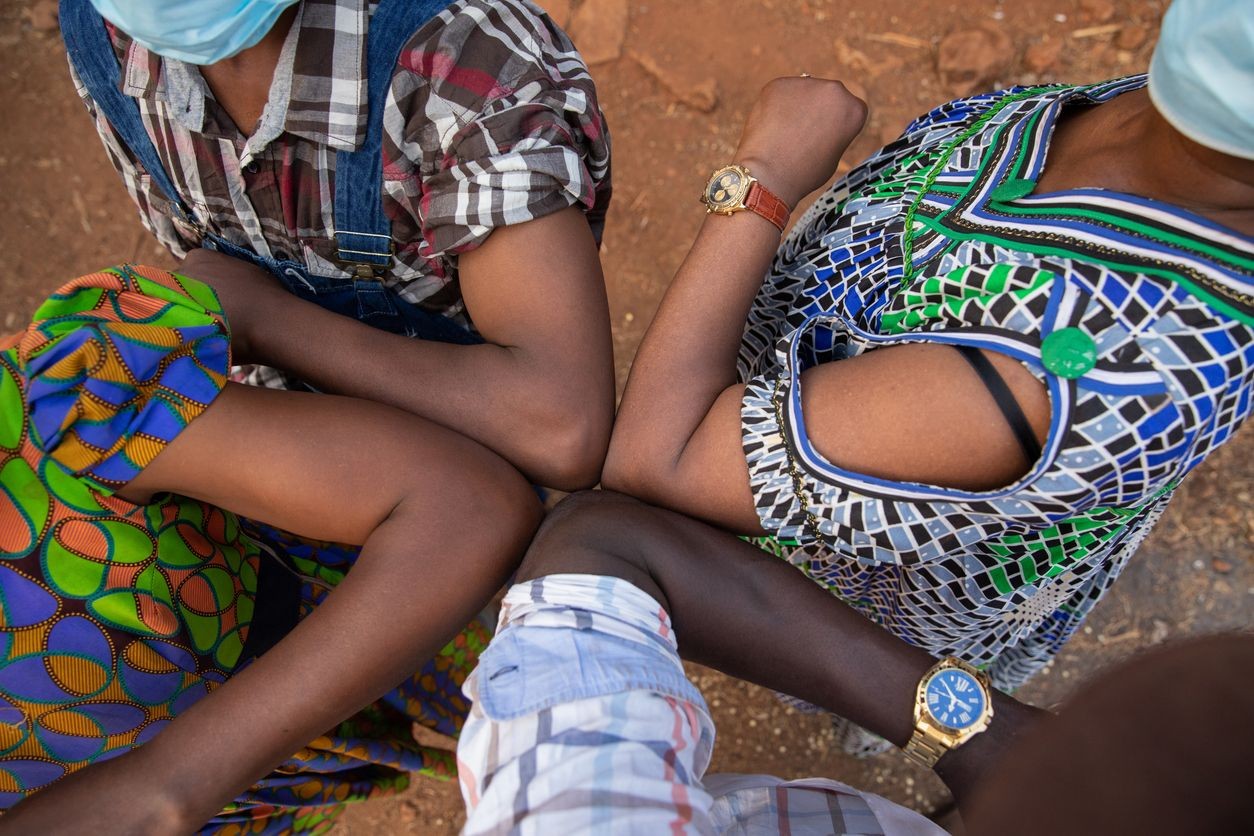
left=903, top=656, right=993, bottom=768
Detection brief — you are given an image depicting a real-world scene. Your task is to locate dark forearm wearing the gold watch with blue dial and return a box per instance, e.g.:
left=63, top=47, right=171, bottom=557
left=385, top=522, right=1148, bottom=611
left=646, top=511, right=1041, bottom=805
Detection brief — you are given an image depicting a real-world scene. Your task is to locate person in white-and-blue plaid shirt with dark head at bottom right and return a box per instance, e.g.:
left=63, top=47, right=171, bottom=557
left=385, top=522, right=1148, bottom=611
left=458, top=491, right=1254, bottom=836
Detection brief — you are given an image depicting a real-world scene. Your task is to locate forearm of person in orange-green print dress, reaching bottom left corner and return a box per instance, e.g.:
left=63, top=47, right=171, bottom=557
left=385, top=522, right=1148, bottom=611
left=4, top=493, right=534, bottom=833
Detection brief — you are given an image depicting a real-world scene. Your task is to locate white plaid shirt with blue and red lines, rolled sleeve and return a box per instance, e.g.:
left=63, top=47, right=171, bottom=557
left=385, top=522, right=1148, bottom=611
left=458, top=574, right=944, bottom=836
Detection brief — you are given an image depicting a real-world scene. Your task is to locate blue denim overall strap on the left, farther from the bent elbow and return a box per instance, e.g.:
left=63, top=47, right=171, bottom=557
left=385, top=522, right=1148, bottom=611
left=59, top=0, right=196, bottom=226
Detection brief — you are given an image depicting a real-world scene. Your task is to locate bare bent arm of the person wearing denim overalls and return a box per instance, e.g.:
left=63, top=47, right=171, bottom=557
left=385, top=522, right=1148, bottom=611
left=183, top=208, right=613, bottom=490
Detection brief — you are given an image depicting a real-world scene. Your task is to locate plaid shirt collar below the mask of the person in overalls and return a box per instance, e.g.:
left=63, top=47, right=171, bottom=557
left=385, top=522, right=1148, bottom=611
left=114, top=0, right=375, bottom=155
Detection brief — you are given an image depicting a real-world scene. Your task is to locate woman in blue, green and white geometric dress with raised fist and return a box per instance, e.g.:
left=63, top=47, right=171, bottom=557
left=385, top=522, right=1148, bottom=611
left=603, top=0, right=1254, bottom=752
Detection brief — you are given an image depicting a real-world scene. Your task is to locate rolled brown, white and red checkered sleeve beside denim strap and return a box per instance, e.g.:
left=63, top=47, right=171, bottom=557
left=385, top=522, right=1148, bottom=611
left=385, top=0, right=609, bottom=257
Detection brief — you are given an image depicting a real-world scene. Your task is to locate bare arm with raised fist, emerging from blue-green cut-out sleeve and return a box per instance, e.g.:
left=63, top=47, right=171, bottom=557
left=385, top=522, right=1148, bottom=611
left=602, top=78, right=1048, bottom=533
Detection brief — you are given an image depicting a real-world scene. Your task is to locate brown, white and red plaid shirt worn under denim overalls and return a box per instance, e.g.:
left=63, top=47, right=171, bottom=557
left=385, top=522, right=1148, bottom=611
left=71, top=0, right=609, bottom=323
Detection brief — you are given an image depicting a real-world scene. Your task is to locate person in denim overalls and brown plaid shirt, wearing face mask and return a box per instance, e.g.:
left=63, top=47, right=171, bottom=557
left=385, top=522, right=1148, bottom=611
left=60, top=0, right=614, bottom=490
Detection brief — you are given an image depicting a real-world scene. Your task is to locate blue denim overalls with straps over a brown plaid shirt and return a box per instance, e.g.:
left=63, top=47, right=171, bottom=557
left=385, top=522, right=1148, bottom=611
left=60, top=0, right=483, bottom=345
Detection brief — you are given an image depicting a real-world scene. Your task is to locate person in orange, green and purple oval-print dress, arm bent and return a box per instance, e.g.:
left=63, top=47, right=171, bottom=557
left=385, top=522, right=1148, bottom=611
left=0, top=266, right=540, bottom=833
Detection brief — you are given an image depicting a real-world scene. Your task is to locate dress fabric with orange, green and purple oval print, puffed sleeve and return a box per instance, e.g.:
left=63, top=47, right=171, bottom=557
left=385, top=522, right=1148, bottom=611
left=0, top=267, right=488, bottom=833
